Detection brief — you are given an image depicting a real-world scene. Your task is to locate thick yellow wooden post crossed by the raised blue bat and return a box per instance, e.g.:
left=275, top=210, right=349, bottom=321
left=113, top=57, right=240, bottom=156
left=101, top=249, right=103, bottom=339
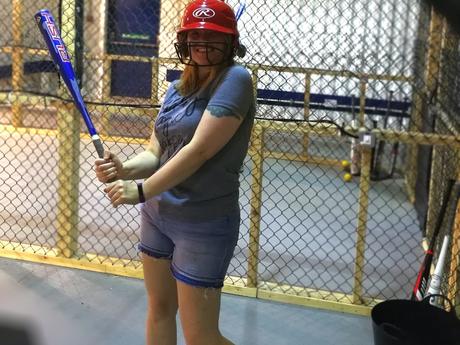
left=56, top=0, right=80, bottom=258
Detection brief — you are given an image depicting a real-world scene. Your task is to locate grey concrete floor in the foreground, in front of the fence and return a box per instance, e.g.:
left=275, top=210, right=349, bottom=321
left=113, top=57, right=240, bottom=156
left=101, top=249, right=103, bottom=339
left=0, top=258, right=373, bottom=345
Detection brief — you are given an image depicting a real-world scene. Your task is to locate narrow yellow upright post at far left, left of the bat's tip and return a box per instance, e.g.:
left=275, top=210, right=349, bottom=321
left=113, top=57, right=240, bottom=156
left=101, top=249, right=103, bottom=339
left=11, top=0, right=24, bottom=127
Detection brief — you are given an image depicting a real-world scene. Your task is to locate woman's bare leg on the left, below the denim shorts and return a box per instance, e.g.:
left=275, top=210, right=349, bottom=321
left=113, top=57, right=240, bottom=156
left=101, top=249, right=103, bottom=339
left=142, top=254, right=178, bottom=345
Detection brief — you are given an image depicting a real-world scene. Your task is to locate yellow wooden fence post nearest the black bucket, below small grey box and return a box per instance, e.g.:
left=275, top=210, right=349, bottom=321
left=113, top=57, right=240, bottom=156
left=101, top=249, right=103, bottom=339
left=353, top=138, right=371, bottom=304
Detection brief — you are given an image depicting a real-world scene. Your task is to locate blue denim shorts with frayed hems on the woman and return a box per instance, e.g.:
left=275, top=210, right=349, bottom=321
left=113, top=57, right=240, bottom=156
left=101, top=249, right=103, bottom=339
left=139, top=203, right=240, bottom=288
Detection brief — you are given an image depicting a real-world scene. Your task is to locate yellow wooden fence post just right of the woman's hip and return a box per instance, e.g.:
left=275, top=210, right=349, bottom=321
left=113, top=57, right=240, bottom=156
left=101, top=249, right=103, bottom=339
left=247, top=124, right=264, bottom=287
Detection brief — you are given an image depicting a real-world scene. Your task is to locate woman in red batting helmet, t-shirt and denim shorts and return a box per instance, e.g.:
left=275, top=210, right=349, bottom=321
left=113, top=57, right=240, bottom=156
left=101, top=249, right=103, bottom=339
left=95, top=0, right=255, bottom=345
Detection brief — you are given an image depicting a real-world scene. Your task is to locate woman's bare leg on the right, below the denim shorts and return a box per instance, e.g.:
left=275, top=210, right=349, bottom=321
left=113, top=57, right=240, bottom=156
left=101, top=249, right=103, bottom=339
left=177, top=281, right=233, bottom=345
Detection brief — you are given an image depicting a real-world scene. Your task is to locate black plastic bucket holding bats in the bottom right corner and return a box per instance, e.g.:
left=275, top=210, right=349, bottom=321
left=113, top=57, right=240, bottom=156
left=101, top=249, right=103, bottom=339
left=371, top=298, right=460, bottom=345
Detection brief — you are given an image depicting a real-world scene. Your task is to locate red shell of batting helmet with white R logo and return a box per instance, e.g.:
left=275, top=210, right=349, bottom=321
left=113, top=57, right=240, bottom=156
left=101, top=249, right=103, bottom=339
left=177, top=0, right=238, bottom=38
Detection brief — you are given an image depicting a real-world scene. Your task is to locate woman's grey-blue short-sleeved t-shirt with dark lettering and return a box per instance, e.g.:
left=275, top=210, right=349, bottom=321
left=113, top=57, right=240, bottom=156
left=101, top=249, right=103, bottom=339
left=148, top=65, right=255, bottom=219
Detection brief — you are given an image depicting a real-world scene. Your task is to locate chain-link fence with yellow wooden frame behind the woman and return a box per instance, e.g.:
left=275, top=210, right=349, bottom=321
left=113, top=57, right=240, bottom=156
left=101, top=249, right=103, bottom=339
left=0, top=0, right=460, bottom=313
